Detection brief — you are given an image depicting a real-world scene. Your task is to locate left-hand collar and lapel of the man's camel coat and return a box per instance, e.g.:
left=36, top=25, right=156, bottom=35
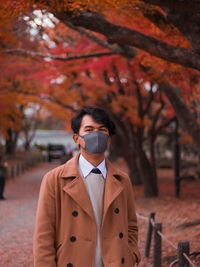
left=61, top=154, right=94, bottom=221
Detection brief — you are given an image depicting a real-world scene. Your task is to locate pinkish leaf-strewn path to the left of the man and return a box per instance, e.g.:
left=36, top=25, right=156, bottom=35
left=0, top=163, right=56, bottom=267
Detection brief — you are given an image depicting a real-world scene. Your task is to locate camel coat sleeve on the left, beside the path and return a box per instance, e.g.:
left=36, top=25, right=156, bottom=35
left=34, top=174, right=56, bottom=267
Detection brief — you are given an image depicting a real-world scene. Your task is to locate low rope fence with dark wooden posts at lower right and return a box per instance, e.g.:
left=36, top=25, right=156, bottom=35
left=137, top=212, right=200, bottom=267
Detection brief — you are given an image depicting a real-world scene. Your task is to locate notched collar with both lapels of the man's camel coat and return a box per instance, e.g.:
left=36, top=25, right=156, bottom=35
left=60, top=153, right=124, bottom=221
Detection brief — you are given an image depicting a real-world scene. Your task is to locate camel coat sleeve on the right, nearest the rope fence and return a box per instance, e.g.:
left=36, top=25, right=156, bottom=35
left=127, top=178, right=141, bottom=263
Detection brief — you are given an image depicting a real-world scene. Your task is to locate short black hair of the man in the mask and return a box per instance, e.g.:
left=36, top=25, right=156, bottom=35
left=71, top=106, right=115, bottom=135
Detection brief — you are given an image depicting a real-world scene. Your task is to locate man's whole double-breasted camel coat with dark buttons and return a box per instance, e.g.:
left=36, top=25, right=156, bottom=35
left=34, top=154, right=140, bottom=267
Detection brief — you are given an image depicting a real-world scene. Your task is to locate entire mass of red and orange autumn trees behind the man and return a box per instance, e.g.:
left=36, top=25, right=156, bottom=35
left=0, top=0, right=200, bottom=197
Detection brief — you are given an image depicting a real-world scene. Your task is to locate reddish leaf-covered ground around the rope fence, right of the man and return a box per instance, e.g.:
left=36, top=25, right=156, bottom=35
left=116, top=160, right=200, bottom=267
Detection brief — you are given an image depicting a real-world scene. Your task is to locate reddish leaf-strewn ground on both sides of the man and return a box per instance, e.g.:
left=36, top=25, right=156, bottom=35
left=0, top=162, right=200, bottom=267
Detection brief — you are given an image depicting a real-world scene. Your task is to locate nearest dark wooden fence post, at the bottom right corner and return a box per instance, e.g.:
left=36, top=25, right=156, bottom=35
left=178, top=241, right=190, bottom=267
